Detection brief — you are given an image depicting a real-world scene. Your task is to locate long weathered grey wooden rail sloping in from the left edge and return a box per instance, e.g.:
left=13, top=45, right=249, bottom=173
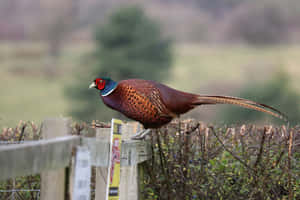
left=0, top=136, right=80, bottom=180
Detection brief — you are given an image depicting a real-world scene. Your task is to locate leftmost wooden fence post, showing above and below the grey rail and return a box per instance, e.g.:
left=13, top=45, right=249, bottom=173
left=41, top=118, right=71, bottom=200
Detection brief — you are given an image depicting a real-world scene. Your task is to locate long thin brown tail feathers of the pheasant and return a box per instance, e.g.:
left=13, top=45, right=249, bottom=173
left=194, top=95, right=288, bottom=121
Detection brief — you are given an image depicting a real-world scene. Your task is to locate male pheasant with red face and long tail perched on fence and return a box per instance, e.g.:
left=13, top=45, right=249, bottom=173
left=89, top=78, right=287, bottom=138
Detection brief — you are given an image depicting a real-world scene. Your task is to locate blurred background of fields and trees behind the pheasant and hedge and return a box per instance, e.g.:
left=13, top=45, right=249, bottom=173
left=0, top=0, right=300, bottom=128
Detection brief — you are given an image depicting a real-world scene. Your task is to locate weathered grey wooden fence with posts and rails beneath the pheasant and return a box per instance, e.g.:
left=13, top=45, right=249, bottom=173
left=0, top=118, right=151, bottom=200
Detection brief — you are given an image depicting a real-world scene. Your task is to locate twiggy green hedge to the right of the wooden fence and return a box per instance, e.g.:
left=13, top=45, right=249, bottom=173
left=142, top=122, right=300, bottom=200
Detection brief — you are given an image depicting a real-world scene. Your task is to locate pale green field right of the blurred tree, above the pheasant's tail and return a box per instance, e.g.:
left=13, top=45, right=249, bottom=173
left=169, top=45, right=300, bottom=90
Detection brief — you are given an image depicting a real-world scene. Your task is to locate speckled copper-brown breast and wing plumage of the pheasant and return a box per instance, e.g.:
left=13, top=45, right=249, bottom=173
left=101, top=79, right=177, bottom=128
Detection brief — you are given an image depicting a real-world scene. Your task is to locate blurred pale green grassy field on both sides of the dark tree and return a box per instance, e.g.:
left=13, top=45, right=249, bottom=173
left=0, top=43, right=300, bottom=128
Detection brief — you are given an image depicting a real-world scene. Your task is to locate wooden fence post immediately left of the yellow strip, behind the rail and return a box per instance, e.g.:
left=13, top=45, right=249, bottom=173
left=95, top=128, right=110, bottom=200
